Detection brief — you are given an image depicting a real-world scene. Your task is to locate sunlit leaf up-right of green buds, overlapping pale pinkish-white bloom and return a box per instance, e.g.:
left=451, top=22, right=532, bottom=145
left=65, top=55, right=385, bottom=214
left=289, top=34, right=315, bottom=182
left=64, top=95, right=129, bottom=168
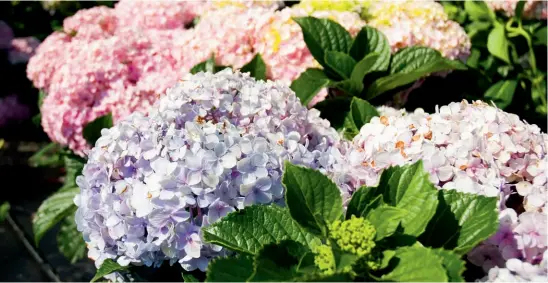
left=377, top=161, right=438, bottom=236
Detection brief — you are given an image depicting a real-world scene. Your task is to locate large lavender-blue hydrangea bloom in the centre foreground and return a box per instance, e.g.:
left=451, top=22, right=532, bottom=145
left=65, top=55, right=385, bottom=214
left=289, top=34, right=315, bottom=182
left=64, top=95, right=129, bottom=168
left=75, top=69, right=339, bottom=271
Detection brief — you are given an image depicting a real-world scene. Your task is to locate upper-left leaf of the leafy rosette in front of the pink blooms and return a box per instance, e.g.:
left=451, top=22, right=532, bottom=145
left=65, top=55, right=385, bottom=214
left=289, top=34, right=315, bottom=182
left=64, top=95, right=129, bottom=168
left=293, top=17, right=352, bottom=66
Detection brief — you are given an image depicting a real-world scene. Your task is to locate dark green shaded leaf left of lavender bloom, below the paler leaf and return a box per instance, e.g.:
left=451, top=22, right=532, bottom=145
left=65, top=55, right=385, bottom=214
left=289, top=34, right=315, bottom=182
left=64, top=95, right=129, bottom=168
left=57, top=215, right=86, bottom=263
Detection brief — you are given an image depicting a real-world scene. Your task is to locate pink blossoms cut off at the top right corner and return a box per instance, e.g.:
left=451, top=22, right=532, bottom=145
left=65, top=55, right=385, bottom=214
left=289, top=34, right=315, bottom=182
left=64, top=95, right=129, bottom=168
left=486, top=0, right=548, bottom=20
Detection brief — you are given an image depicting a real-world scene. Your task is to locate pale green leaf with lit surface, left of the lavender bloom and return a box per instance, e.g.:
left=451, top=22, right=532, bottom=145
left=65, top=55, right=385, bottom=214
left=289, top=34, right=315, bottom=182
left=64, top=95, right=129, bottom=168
left=32, top=187, right=80, bottom=245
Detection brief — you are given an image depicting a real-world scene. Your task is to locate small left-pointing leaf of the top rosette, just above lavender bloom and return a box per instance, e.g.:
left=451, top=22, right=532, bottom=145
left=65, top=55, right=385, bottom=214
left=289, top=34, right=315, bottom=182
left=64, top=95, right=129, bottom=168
left=290, top=69, right=331, bottom=105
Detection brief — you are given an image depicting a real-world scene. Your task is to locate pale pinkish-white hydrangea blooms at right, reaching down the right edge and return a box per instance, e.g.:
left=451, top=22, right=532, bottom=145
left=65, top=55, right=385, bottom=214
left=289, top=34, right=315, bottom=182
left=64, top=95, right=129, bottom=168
left=332, top=101, right=548, bottom=280
